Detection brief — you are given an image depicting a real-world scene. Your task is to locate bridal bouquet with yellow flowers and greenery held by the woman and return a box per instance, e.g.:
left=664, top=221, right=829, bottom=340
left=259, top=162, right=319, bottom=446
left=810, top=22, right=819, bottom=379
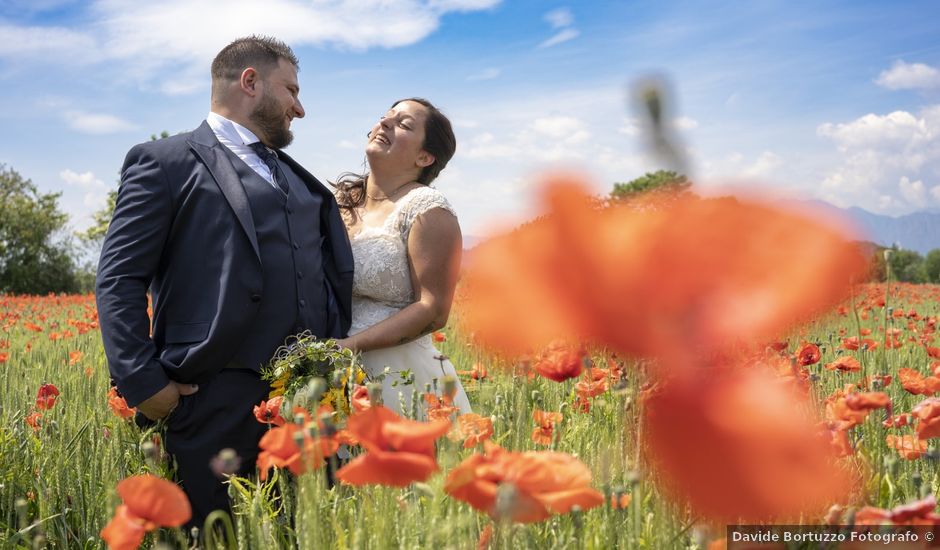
left=261, top=331, right=366, bottom=415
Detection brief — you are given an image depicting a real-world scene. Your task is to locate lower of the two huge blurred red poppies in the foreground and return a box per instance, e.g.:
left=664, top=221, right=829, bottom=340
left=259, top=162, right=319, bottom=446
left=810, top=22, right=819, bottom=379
left=644, top=370, right=850, bottom=522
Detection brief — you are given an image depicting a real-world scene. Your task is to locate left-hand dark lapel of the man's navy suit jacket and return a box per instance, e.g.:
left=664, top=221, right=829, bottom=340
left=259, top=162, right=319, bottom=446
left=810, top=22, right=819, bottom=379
left=189, top=122, right=261, bottom=262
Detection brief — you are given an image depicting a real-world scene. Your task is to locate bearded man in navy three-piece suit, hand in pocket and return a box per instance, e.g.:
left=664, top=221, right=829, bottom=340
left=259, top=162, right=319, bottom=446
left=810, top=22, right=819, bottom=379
left=96, top=36, right=353, bottom=526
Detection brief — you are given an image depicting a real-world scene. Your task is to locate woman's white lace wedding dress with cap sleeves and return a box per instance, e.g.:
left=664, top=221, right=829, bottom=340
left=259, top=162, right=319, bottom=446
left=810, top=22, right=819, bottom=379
left=349, top=186, right=470, bottom=418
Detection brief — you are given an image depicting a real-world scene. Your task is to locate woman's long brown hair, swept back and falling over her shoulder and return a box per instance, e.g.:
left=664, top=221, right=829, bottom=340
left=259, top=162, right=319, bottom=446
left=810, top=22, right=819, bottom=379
left=328, top=97, right=457, bottom=223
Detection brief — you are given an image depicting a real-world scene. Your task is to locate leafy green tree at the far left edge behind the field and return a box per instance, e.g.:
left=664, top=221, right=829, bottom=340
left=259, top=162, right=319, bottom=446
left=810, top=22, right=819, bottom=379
left=0, top=164, right=77, bottom=294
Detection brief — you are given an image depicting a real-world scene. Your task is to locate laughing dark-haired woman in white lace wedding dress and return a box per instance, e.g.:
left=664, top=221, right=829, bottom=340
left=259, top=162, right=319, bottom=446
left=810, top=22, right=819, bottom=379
left=333, top=98, right=470, bottom=416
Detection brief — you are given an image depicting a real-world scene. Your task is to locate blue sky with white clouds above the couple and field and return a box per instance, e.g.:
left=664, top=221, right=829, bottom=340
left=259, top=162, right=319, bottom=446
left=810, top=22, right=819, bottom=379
left=0, top=0, right=940, bottom=242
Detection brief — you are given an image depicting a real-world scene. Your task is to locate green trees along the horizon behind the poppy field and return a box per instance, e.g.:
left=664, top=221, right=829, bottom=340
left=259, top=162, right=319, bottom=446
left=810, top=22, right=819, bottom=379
left=0, top=165, right=940, bottom=294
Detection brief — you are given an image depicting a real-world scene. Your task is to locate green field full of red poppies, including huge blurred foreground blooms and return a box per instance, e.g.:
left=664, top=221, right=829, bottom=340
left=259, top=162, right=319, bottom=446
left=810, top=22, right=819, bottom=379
left=0, top=182, right=940, bottom=548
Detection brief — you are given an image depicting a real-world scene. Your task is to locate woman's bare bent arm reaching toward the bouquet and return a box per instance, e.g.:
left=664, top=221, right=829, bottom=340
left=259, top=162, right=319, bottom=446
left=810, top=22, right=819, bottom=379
left=338, top=208, right=463, bottom=351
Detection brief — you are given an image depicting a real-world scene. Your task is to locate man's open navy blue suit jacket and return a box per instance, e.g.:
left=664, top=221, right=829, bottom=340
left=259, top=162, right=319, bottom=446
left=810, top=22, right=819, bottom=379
left=96, top=122, right=353, bottom=406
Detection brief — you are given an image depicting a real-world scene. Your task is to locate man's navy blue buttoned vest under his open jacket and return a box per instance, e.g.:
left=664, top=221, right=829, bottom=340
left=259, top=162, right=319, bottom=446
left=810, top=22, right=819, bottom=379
left=224, top=147, right=338, bottom=370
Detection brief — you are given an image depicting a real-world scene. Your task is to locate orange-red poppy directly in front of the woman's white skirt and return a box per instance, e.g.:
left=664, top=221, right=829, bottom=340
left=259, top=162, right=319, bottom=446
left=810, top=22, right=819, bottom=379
left=336, top=406, right=450, bottom=487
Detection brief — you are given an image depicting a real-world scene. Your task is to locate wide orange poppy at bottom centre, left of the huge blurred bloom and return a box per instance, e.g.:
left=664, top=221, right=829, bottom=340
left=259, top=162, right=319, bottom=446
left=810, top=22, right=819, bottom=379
left=444, top=441, right=604, bottom=523
